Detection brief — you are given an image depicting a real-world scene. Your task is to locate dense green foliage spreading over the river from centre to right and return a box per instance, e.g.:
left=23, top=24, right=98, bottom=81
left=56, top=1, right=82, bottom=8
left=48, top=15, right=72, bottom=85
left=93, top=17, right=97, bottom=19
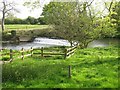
left=43, top=2, right=115, bottom=48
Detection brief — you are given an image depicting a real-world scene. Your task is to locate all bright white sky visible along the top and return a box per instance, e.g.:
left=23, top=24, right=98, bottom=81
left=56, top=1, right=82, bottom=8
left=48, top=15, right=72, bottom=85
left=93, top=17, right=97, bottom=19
left=0, top=0, right=119, bottom=19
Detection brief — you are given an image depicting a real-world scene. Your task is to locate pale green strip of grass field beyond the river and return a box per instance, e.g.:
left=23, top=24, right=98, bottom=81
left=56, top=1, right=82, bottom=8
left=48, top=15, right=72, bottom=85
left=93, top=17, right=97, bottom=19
left=5, top=24, right=48, bottom=31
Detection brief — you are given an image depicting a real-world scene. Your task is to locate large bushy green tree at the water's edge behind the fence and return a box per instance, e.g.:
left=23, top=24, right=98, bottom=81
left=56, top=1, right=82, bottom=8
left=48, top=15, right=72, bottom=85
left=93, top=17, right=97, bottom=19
left=43, top=2, right=98, bottom=47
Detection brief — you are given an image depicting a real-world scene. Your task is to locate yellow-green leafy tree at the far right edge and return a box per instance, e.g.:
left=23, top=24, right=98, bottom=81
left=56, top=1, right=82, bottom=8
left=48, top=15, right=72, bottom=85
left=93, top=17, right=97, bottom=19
left=104, top=0, right=120, bottom=37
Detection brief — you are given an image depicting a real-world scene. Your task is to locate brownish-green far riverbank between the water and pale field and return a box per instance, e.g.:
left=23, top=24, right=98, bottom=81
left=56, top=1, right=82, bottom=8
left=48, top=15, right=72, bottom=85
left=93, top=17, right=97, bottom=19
left=2, top=25, right=61, bottom=42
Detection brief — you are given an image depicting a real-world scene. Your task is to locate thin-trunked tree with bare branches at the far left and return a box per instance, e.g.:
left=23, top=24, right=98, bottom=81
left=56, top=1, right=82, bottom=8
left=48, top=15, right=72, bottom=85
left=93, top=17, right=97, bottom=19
left=0, top=0, right=18, bottom=31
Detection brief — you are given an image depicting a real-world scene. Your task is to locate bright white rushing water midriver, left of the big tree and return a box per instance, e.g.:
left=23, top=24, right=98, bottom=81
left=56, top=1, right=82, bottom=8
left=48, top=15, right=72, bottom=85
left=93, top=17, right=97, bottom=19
left=33, top=38, right=70, bottom=46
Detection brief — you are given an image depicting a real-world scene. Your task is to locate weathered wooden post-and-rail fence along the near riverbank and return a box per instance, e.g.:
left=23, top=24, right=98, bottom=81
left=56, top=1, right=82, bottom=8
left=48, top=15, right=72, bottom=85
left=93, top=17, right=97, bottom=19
left=0, top=46, right=77, bottom=62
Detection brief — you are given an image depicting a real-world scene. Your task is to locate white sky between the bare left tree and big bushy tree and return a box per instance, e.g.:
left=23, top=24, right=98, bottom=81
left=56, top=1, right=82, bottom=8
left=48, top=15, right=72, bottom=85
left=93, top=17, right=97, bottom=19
left=0, top=0, right=50, bottom=19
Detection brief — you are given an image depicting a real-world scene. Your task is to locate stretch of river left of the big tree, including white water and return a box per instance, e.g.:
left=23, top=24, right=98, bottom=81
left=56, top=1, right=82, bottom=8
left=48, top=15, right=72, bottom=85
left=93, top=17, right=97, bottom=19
left=3, top=37, right=70, bottom=50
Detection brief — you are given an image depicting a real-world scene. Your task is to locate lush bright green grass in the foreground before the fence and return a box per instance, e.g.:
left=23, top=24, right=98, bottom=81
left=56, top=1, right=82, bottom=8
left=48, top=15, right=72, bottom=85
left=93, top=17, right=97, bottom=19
left=2, top=47, right=120, bottom=88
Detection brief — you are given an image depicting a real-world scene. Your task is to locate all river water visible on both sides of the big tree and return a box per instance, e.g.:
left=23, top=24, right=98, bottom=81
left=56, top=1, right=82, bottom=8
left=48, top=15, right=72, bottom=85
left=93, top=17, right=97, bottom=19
left=3, top=37, right=120, bottom=50
